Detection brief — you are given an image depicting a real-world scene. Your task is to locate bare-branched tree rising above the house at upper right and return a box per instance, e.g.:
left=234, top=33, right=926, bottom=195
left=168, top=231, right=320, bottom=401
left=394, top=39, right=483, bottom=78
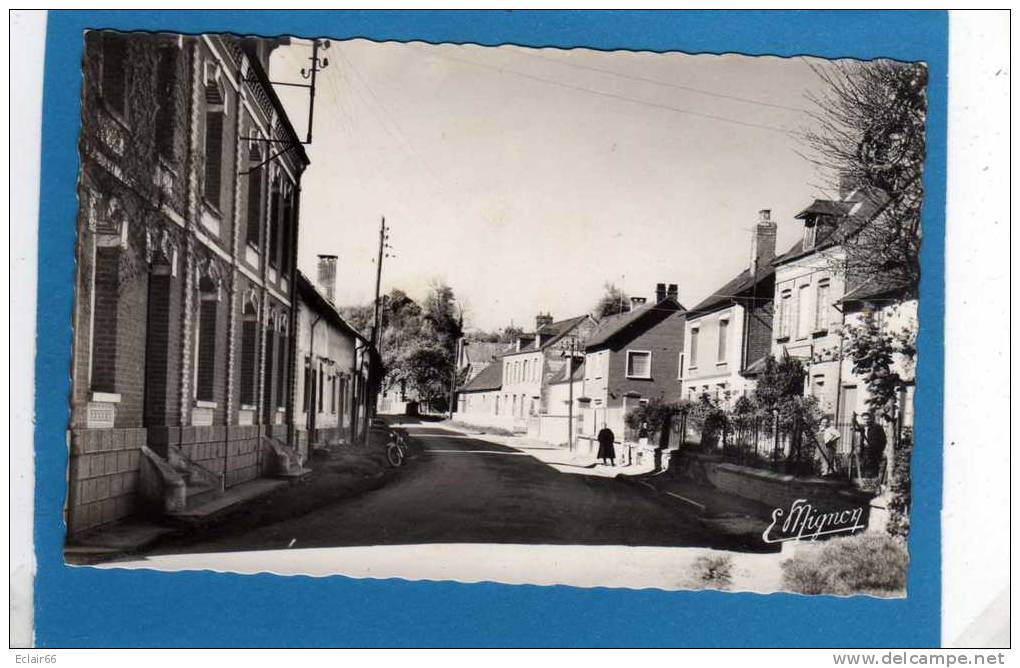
left=802, top=60, right=928, bottom=296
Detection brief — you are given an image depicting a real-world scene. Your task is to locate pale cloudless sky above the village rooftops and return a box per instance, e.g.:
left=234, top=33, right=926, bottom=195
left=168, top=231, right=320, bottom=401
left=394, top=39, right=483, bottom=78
left=271, top=40, right=830, bottom=330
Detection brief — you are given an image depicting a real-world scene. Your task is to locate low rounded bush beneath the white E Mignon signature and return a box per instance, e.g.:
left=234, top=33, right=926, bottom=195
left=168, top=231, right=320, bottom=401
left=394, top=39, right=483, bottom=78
left=782, top=533, right=909, bottom=597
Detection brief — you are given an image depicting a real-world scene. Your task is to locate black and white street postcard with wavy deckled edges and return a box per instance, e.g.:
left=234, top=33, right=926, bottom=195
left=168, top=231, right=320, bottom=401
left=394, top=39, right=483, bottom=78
left=61, top=29, right=928, bottom=598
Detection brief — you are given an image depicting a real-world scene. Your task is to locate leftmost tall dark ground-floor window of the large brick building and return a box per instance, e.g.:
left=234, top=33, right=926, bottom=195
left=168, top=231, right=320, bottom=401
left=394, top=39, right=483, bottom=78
left=92, top=248, right=120, bottom=393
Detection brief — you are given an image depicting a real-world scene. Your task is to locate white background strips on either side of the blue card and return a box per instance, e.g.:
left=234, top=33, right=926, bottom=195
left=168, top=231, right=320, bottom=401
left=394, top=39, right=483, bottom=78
left=3, top=5, right=1013, bottom=652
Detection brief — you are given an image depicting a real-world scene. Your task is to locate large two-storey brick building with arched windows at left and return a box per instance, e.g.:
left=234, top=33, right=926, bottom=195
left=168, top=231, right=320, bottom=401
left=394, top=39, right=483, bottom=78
left=66, top=32, right=308, bottom=535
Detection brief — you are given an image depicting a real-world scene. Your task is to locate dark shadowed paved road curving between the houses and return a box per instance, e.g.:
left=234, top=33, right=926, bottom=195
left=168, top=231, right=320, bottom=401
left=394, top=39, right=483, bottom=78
left=150, top=424, right=758, bottom=552
